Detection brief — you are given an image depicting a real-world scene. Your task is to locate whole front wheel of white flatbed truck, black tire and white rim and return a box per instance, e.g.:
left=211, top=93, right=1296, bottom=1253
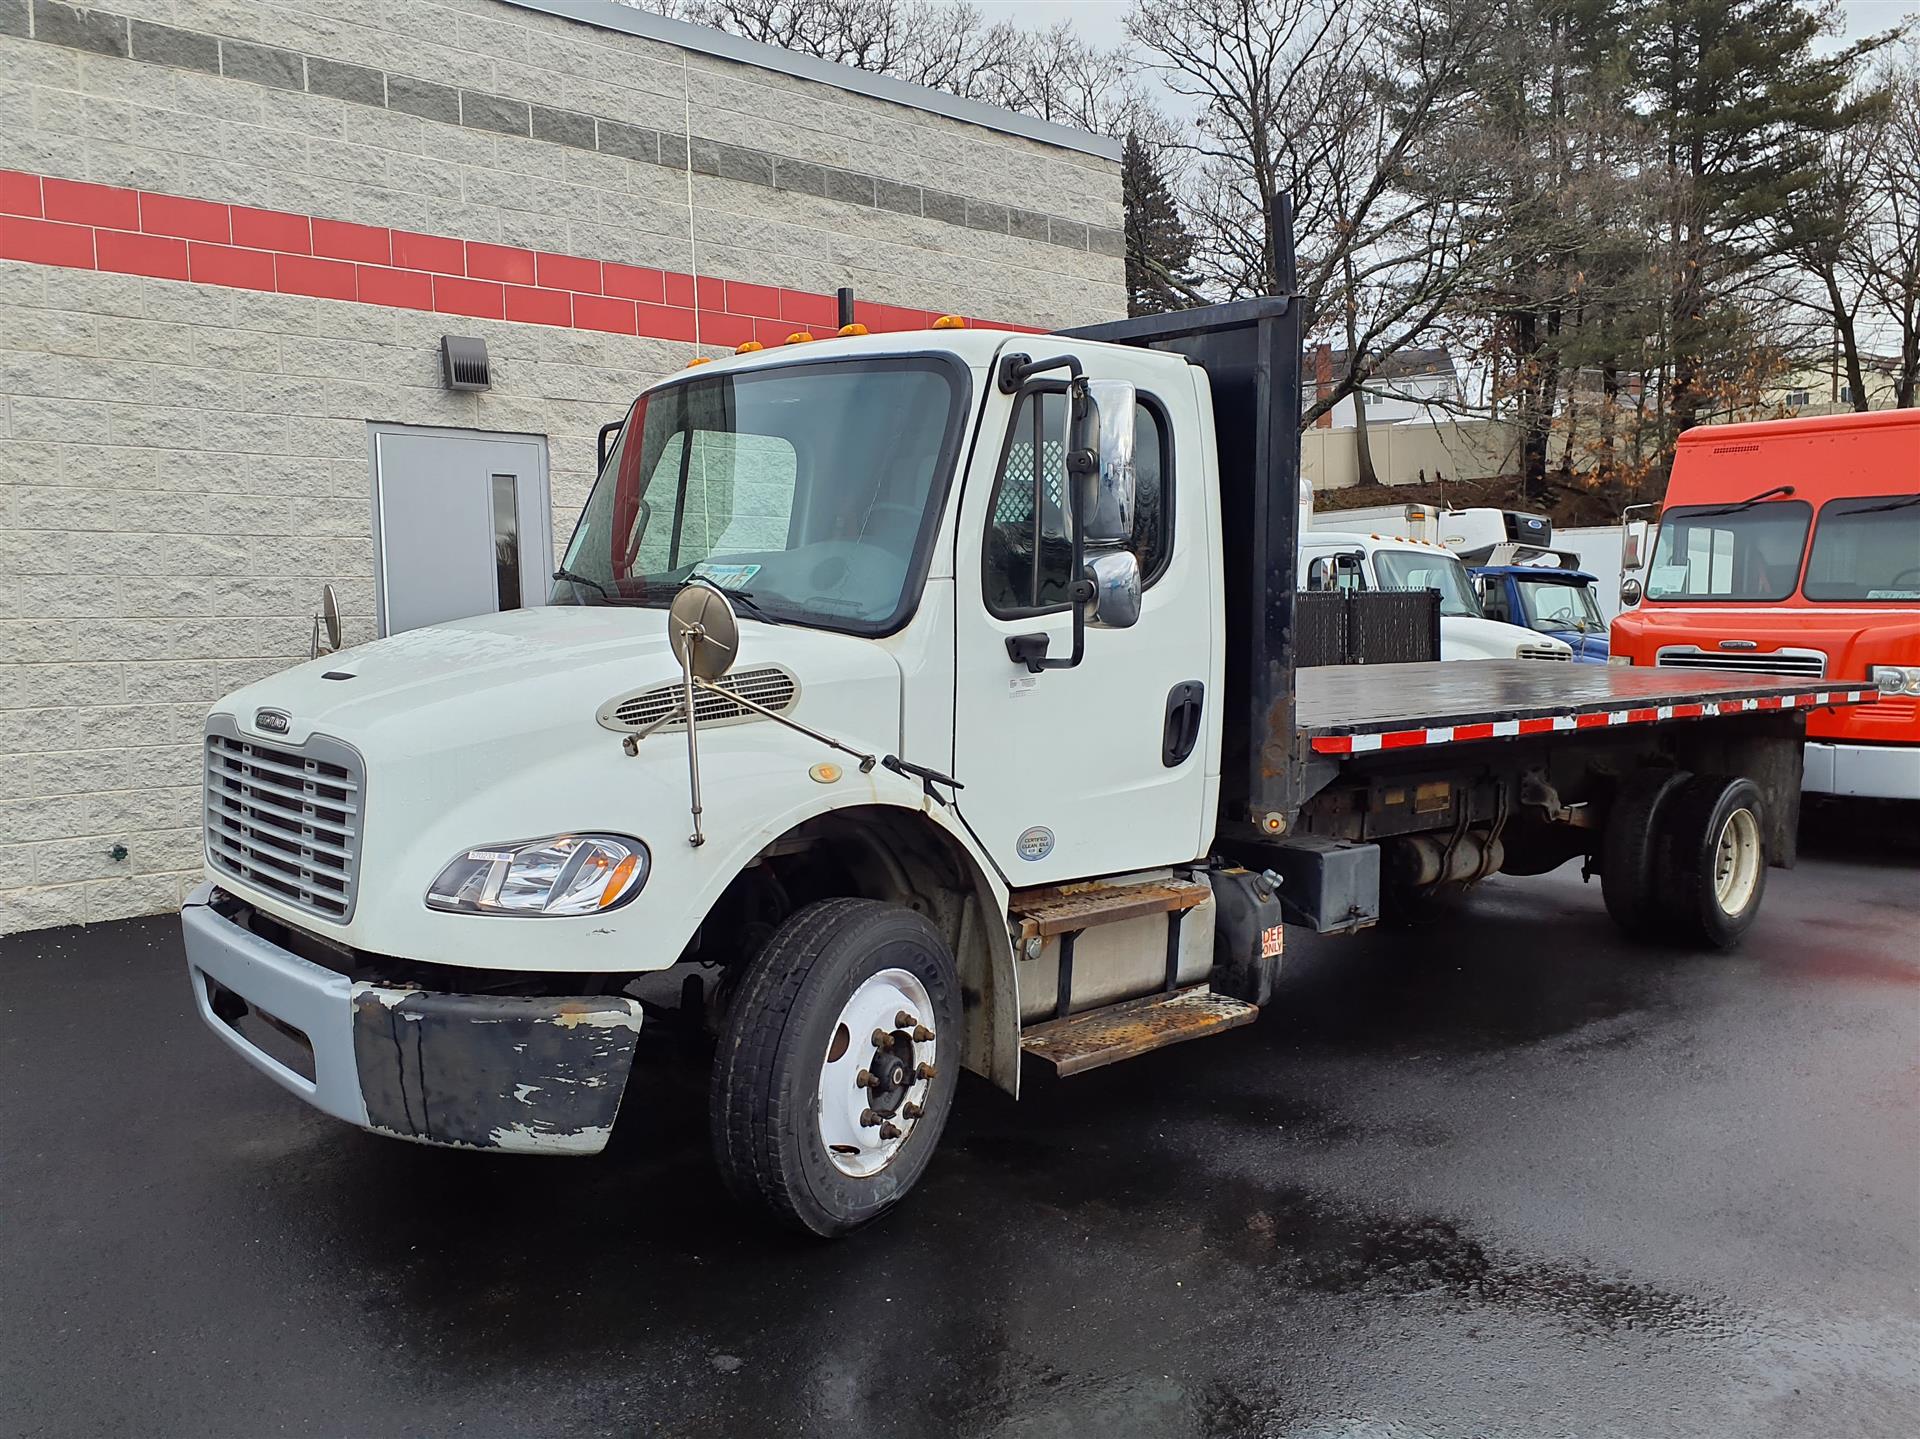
left=710, top=899, right=962, bottom=1237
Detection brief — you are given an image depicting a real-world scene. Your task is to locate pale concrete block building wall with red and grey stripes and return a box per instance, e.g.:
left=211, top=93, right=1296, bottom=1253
left=0, top=0, right=1125, bottom=932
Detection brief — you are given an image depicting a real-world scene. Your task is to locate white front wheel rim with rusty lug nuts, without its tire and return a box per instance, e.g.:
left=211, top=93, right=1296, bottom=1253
left=820, top=970, right=939, bottom=1180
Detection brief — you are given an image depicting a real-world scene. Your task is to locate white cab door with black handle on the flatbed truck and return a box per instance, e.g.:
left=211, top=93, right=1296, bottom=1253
left=952, top=350, right=1219, bottom=888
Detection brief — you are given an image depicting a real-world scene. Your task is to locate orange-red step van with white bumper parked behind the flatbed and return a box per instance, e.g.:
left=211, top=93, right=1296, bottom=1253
left=1611, top=409, right=1920, bottom=799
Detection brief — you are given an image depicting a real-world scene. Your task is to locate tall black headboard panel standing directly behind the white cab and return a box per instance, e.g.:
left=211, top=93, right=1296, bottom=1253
left=1062, top=290, right=1308, bottom=841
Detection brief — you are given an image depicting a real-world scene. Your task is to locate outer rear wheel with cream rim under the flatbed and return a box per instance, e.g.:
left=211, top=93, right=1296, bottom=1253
left=1655, top=774, right=1766, bottom=949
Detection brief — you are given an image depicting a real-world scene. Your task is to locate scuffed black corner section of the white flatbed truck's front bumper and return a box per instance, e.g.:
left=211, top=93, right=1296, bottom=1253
left=353, top=984, right=641, bottom=1155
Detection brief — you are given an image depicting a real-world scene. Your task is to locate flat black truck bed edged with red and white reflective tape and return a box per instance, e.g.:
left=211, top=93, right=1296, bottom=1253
left=1294, top=659, right=1880, bottom=755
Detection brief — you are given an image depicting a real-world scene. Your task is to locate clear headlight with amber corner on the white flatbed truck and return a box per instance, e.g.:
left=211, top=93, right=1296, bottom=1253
left=426, top=834, right=647, bottom=916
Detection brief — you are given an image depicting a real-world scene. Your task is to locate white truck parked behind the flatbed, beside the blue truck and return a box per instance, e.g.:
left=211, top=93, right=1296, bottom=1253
left=1300, top=528, right=1572, bottom=661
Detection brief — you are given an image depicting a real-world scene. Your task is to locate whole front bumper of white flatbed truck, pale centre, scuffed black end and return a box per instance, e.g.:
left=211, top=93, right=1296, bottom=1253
left=180, top=884, right=641, bottom=1155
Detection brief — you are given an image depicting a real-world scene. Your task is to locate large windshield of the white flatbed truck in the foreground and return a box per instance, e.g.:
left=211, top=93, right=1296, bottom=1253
left=553, top=357, right=966, bottom=634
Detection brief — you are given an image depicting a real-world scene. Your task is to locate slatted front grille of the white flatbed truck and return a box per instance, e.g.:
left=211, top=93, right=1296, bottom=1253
left=205, top=715, right=367, bottom=920
